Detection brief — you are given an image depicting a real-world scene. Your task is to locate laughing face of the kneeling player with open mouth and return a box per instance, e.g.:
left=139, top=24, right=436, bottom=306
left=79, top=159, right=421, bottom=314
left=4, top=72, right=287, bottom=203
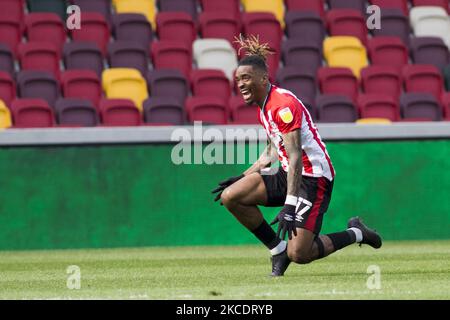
left=236, top=65, right=267, bottom=105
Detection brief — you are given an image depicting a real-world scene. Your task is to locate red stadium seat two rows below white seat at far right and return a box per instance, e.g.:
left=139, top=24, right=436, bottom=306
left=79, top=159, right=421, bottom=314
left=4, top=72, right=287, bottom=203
left=402, top=64, right=444, bottom=101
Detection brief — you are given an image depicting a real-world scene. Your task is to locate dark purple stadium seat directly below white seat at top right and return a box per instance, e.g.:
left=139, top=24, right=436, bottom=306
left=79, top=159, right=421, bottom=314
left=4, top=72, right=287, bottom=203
left=411, top=35, right=450, bottom=70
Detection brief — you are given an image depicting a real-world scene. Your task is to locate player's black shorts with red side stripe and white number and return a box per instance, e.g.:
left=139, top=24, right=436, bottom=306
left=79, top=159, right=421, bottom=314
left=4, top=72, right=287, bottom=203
left=261, top=168, right=333, bottom=234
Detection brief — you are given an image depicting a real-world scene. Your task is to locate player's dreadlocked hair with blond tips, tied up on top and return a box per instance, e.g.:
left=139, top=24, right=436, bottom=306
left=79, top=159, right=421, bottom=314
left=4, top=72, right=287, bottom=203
left=235, top=34, right=273, bottom=72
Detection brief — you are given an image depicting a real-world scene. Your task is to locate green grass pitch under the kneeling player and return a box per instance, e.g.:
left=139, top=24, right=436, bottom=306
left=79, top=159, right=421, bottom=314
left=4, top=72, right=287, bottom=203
left=0, top=240, right=450, bottom=300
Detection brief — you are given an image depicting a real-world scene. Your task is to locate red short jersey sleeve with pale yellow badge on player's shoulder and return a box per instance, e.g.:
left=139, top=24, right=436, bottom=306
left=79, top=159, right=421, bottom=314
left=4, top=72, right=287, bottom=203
left=274, top=100, right=303, bottom=133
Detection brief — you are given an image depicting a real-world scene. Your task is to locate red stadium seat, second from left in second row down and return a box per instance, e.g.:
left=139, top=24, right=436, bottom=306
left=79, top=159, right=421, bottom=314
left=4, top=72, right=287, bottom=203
left=25, top=13, right=67, bottom=52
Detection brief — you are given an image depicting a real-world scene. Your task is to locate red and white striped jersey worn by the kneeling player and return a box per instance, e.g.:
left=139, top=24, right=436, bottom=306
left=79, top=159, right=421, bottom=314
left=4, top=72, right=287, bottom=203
left=259, top=85, right=335, bottom=181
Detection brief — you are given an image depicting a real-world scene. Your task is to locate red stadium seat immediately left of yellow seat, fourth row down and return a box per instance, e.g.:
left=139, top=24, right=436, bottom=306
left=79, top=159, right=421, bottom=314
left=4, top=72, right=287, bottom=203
left=61, top=70, right=102, bottom=107
